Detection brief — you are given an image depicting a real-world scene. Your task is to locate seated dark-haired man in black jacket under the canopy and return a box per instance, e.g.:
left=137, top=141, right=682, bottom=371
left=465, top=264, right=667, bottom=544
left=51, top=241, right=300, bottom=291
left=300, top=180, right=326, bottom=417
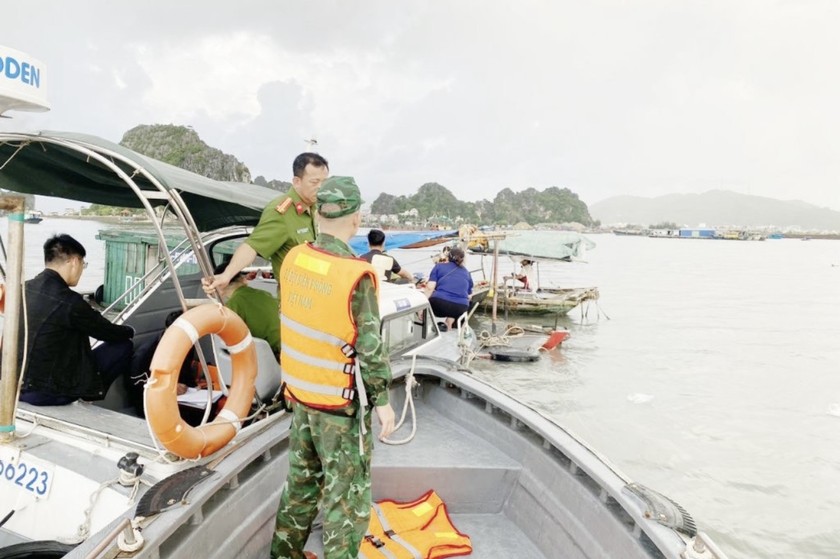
left=20, top=235, right=134, bottom=406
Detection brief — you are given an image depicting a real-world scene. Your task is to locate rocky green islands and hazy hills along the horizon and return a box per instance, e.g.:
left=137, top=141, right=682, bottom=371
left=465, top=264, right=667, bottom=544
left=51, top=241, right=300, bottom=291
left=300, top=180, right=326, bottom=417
left=31, top=124, right=840, bottom=233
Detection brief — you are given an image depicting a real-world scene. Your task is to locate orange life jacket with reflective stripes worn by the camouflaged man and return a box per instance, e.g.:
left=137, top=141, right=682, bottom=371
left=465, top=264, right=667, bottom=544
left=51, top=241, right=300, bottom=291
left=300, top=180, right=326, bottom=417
left=280, top=244, right=379, bottom=410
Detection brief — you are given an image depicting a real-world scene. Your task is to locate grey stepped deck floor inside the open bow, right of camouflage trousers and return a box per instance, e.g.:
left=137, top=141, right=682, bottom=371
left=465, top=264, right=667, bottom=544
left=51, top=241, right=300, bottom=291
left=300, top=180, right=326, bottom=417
left=307, top=401, right=552, bottom=559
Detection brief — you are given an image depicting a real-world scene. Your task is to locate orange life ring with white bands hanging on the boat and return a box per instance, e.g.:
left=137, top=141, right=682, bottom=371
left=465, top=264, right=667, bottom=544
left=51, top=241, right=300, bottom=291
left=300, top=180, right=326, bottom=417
left=145, top=303, right=257, bottom=458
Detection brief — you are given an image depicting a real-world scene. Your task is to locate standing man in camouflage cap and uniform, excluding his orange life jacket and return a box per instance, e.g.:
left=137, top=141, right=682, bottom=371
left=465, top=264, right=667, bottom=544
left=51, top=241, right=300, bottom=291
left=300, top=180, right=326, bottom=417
left=271, top=177, right=394, bottom=559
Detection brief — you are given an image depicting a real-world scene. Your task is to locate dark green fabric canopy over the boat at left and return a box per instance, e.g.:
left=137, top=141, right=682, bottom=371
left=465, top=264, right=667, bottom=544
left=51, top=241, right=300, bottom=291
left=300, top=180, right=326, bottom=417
left=0, top=131, right=280, bottom=231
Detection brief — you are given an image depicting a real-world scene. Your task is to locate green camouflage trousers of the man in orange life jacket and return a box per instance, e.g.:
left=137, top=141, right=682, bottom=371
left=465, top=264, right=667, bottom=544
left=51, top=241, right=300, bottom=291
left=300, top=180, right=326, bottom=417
left=271, top=403, right=373, bottom=559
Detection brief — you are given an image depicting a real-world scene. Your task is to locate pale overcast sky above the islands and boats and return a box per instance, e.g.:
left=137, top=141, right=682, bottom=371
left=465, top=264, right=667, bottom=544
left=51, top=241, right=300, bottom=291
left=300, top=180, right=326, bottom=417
left=0, top=0, right=840, bottom=210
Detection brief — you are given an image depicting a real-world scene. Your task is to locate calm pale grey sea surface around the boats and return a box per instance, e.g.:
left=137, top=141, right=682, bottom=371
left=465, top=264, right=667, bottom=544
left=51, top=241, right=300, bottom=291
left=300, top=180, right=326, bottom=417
left=0, top=218, right=840, bottom=559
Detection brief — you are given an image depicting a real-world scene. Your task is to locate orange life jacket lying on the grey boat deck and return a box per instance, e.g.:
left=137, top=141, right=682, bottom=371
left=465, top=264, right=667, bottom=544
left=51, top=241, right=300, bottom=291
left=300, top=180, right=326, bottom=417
left=359, top=491, right=472, bottom=559
